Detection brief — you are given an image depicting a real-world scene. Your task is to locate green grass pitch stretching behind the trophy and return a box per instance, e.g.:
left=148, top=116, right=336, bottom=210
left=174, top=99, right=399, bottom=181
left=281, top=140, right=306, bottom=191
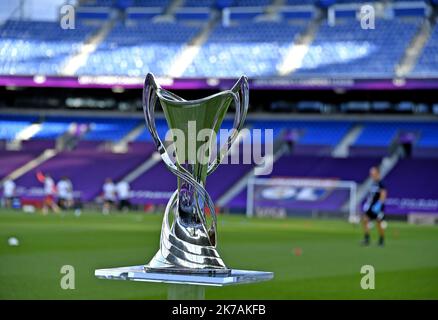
left=0, top=210, right=438, bottom=299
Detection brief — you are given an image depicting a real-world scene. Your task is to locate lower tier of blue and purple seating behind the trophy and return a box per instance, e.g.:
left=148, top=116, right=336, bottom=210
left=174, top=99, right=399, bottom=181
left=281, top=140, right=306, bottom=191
left=0, top=111, right=438, bottom=213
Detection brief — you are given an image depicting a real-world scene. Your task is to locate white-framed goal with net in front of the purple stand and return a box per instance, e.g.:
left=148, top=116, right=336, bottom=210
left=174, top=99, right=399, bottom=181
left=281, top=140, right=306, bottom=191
left=246, top=177, right=359, bottom=223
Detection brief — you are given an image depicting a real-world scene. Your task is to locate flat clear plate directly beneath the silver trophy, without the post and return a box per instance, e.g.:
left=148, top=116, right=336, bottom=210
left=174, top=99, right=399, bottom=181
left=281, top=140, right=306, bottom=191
left=94, top=265, right=274, bottom=287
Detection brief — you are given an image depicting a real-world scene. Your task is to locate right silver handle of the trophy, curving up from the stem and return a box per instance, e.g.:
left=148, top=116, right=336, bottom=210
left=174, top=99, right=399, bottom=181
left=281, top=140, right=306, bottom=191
left=207, top=76, right=249, bottom=175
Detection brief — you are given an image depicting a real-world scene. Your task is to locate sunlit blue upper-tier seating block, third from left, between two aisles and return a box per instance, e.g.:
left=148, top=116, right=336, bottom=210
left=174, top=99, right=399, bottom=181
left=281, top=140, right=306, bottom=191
left=184, top=21, right=306, bottom=78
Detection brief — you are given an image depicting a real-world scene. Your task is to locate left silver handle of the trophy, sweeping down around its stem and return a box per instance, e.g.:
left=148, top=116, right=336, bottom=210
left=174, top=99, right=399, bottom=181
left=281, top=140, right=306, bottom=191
left=143, top=73, right=217, bottom=247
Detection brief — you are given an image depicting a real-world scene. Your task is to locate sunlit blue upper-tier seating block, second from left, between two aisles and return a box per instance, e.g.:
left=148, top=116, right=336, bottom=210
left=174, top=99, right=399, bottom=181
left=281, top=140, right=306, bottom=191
left=78, top=21, right=200, bottom=77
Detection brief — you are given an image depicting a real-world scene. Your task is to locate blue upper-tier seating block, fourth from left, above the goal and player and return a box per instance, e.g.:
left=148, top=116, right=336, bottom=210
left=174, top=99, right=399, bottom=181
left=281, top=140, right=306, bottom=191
left=294, top=18, right=422, bottom=78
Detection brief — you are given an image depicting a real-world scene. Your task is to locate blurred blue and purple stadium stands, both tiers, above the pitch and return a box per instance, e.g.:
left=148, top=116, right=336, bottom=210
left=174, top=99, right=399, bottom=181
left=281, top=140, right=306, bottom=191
left=0, top=0, right=438, bottom=219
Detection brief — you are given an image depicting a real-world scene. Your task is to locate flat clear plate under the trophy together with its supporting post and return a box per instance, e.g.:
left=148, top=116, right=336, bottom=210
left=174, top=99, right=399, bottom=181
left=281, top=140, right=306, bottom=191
left=94, top=265, right=274, bottom=300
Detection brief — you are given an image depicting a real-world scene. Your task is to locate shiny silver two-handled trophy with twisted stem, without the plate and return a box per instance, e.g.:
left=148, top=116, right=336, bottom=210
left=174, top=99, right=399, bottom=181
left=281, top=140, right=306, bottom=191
left=143, top=74, right=248, bottom=274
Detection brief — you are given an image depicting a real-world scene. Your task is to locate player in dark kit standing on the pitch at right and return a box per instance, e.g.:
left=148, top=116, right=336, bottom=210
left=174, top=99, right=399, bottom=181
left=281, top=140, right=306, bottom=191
left=362, top=167, right=387, bottom=246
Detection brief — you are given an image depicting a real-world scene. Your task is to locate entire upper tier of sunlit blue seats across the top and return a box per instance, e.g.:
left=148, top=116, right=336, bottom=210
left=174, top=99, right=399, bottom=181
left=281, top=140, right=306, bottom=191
left=0, top=0, right=432, bottom=78
